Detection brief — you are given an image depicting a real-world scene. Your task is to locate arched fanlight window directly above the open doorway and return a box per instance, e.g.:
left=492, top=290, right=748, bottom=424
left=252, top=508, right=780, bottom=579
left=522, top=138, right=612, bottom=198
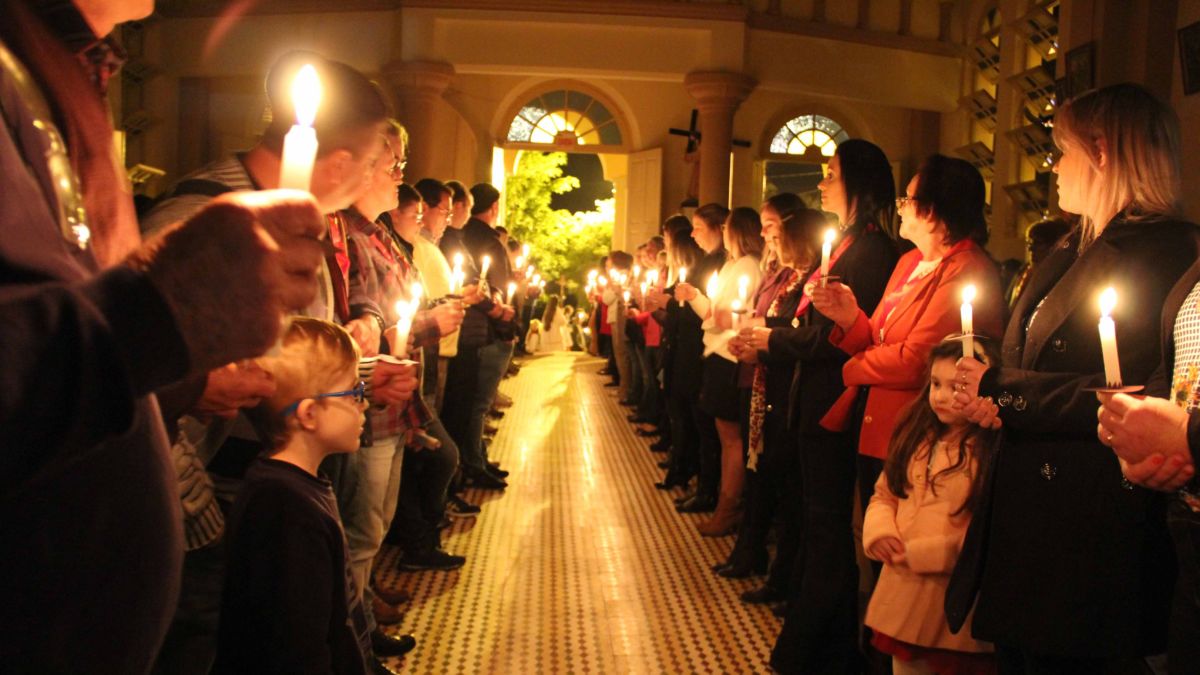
left=506, top=89, right=622, bottom=147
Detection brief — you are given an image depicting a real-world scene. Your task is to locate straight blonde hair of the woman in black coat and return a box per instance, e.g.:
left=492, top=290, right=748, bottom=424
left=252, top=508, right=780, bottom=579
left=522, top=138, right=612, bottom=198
left=1054, top=84, right=1182, bottom=246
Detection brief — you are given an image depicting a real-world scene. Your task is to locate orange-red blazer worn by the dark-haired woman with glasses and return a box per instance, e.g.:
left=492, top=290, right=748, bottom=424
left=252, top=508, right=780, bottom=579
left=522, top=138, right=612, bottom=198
left=821, top=240, right=1004, bottom=459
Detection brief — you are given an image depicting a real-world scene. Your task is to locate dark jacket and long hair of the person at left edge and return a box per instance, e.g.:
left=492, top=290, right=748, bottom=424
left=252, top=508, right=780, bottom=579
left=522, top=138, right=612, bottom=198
left=0, top=0, right=188, bottom=674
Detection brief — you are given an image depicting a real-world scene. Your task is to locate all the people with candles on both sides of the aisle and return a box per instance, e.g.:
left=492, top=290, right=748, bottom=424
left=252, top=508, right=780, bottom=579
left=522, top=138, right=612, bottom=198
left=7, top=0, right=1200, bottom=674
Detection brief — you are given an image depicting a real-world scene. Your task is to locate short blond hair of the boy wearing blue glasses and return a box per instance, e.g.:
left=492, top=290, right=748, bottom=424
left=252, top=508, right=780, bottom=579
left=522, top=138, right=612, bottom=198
left=247, top=317, right=361, bottom=448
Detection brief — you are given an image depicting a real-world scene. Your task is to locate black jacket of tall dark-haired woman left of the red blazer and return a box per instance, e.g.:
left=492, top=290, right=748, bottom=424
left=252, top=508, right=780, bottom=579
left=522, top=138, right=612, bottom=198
left=768, top=228, right=898, bottom=434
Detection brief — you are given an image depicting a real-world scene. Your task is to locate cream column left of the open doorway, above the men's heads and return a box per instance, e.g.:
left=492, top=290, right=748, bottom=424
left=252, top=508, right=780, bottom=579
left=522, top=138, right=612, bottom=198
left=383, top=61, right=455, bottom=183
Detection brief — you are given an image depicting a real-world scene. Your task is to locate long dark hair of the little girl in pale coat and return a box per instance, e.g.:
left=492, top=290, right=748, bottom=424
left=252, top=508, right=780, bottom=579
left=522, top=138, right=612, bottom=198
left=883, top=335, right=1001, bottom=515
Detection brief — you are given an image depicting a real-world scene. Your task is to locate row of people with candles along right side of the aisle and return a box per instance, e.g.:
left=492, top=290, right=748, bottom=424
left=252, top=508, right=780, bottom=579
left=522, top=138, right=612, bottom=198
left=587, top=85, right=1200, bottom=674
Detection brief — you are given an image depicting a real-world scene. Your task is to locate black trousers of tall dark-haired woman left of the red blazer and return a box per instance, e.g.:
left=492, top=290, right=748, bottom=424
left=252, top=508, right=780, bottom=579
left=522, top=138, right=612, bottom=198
left=772, top=432, right=859, bottom=673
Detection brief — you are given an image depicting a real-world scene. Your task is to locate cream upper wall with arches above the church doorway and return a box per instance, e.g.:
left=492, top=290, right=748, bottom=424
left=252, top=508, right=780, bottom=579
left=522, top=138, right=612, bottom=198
left=140, top=0, right=961, bottom=230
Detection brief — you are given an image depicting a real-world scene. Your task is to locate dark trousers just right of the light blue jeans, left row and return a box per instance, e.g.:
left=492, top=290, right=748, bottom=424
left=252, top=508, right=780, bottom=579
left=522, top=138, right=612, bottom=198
left=391, top=420, right=458, bottom=554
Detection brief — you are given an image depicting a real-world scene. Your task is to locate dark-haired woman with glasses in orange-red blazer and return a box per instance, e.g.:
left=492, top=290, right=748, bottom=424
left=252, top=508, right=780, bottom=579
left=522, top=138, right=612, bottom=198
left=812, top=155, right=1004, bottom=510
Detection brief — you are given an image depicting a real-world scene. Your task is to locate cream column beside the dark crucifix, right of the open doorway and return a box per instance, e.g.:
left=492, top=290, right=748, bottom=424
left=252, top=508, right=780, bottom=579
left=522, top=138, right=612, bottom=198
left=683, top=71, right=757, bottom=205
